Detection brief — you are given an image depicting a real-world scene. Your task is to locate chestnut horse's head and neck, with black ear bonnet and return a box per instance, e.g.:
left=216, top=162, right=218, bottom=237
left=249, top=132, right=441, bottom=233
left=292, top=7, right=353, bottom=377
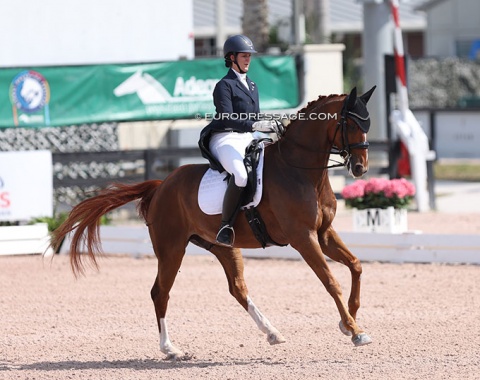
left=277, top=86, right=375, bottom=177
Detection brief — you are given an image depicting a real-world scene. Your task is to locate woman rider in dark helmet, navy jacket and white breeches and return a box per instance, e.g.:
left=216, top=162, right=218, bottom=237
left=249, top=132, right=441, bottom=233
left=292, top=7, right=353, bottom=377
left=199, top=35, right=278, bottom=247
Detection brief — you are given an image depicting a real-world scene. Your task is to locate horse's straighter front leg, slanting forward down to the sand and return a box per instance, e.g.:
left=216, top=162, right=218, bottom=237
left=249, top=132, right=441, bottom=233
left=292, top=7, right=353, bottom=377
left=291, top=231, right=372, bottom=346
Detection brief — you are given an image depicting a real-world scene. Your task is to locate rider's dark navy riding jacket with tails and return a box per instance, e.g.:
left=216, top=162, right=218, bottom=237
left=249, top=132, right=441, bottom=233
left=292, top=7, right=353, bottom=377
left=198, top=69, right=260, bottom=171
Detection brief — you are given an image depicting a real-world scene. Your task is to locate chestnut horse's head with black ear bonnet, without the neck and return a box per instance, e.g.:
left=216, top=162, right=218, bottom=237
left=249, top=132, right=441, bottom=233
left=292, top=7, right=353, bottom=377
left=333, top=86, right=376, bottom=178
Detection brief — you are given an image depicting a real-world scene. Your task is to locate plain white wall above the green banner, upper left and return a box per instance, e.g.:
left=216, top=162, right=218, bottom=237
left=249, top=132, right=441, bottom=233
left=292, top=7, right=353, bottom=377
left=0, top=0, right=194, bottom=67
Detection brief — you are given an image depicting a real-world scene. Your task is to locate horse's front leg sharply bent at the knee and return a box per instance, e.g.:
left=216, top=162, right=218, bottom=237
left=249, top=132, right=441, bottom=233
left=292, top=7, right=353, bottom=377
left=318, top=227, right=371, bottom=345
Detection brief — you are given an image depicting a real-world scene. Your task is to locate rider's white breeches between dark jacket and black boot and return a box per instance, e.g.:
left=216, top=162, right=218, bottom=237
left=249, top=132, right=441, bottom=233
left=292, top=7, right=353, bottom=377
left=210, top=132, right=255, bottom=187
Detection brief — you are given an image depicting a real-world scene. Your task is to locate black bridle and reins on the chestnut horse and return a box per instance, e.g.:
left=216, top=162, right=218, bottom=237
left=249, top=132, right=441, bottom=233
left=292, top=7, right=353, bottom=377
left=277, top=96, right=370, bottom=170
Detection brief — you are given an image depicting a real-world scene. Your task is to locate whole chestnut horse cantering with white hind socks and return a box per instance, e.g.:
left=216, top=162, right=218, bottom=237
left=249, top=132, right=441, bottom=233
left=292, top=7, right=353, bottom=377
left=51, top=88, right=374, bottom=359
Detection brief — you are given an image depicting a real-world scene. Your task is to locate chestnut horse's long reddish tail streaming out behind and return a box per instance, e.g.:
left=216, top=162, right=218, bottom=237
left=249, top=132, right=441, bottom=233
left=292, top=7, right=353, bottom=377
left=50, top=180, right=162, bottom=276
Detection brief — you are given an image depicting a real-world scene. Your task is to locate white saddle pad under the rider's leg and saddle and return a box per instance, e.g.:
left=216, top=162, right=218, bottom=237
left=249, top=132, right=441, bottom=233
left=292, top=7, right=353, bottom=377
left=198, top=149, right=264, bottom=215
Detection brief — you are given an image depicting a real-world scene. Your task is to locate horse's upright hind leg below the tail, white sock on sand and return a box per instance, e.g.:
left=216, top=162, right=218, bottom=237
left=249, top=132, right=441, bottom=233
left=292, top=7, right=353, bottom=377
left=150, top=240, right=186, bottom=359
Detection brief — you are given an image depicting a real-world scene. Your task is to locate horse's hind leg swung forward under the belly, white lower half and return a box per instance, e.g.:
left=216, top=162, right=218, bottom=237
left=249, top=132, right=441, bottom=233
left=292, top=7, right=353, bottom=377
left=210, top=246, right=285, bottom=344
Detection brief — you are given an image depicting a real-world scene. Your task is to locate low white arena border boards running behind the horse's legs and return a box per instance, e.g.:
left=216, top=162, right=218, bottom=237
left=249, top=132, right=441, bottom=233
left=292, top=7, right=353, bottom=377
left=60, top=226, right=480, bottom=264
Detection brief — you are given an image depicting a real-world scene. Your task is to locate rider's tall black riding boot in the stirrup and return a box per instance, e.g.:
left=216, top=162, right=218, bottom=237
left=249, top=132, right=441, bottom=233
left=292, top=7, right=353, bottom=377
left=216, top=175, right=245, bottom=247
